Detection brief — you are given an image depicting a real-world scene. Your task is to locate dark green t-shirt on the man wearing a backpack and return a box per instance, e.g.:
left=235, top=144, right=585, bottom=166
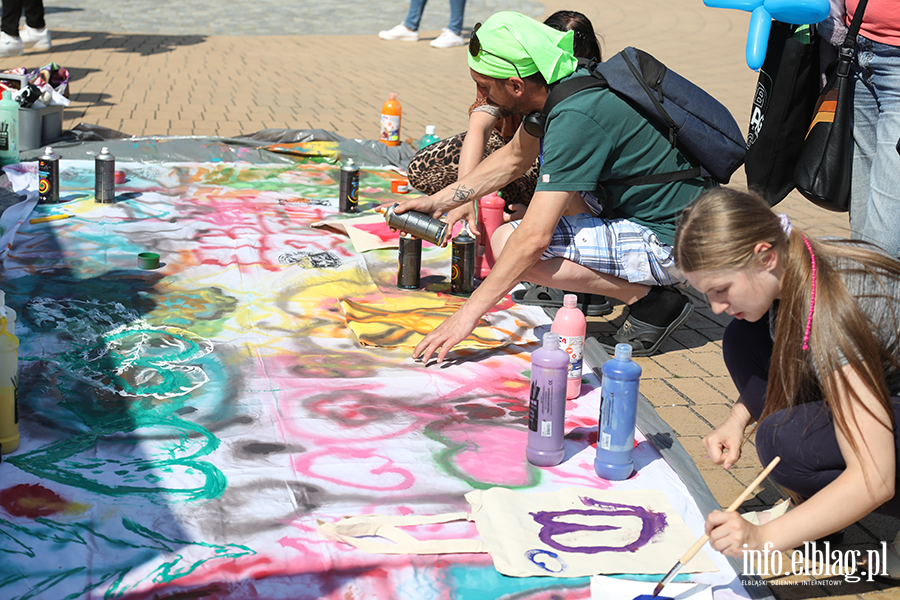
left=536, top=68, right=710, bottom=244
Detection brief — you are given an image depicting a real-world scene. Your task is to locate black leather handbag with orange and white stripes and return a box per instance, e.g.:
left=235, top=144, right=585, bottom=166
left=794, top=0, right=867, bottom=212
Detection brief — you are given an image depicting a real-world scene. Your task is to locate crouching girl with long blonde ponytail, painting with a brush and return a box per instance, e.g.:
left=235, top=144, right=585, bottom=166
left=675, top=189, right=900, bottom=577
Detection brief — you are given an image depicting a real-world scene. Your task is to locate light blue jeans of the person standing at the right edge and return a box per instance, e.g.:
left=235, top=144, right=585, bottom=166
left=850, top=36, right=900, bottom=256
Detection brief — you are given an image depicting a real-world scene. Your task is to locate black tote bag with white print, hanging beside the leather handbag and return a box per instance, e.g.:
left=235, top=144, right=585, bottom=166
left=744, top=21, right=820, bottom=206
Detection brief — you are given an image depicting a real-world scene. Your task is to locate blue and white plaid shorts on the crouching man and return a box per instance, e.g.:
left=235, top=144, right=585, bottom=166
left=512, top=213, right=684, bottom=285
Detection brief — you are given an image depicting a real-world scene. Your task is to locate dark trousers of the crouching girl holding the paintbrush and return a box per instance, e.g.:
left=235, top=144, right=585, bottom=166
left=722, top=316, right=900, bottom=516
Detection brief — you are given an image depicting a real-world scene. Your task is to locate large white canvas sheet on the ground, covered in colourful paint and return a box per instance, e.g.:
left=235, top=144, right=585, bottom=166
left=0, top=159, right=740, bottom=600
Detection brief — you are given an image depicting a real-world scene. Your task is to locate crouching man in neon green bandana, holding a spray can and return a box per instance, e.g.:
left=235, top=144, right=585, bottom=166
left=397, top=12, right=709, bottom=362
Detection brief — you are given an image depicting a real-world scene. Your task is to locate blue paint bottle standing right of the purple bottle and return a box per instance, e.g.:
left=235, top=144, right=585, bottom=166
left=594, top=344, right=641, bottom=481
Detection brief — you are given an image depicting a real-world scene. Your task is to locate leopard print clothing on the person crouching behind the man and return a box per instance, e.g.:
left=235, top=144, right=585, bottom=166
left=406, top=130, right=540, bottom=207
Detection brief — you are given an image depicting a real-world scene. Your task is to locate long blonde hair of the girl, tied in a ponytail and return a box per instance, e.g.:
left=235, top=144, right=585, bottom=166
left=674, top=188, right=900, bottom=472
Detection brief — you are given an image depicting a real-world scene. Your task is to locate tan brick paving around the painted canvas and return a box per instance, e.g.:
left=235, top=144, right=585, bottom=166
left=7, top=0, right=900, bottom=600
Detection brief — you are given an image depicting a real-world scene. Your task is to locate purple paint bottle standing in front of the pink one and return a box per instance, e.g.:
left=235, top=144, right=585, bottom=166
left=525, top=332, right=569, bottom=467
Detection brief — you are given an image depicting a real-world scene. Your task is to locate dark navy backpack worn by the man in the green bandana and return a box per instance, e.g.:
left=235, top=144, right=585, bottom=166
left=523, top=47, right=747, bottom=185
